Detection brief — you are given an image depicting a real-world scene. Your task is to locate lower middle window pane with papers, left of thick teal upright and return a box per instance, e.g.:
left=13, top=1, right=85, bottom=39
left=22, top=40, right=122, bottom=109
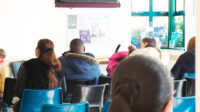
left=153, top=17, right=168, bottom=48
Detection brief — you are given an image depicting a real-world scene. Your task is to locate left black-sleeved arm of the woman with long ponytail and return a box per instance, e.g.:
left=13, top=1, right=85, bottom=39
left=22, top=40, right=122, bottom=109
left=15, top=65, right=26, bottom=98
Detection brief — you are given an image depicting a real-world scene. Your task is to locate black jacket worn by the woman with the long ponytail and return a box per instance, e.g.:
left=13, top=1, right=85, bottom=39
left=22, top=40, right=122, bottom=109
left=16, top=59, right=66, bottom=99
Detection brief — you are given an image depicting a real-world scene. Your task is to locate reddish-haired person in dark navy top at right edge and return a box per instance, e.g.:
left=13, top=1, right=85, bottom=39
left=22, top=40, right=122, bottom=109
left=171, top=37, right=195, bottom=80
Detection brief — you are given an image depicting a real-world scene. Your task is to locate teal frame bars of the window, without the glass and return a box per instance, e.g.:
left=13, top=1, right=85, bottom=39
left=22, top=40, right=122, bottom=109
left=131, top=0, right=185, bottom=50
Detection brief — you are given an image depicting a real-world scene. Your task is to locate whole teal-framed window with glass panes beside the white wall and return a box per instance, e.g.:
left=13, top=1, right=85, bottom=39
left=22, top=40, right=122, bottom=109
left=131, top=0, right=185, bottom=49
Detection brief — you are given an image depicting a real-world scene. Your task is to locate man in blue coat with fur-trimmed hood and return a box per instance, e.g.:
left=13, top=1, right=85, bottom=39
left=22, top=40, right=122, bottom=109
left=59, top=39, right=101, bottom=84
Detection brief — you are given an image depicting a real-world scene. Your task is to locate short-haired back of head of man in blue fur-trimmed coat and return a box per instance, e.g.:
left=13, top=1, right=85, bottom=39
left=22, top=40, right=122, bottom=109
left=70, top=38, right=85, bottom=53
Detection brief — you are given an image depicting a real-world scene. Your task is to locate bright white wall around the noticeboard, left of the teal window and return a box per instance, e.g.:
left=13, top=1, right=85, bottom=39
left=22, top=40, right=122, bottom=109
left=0, top=0, right=131, bottom=59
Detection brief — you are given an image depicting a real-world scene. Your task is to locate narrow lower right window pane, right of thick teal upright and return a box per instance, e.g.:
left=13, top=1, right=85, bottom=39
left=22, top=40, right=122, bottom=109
left=169, top=16, right=184, bottom=48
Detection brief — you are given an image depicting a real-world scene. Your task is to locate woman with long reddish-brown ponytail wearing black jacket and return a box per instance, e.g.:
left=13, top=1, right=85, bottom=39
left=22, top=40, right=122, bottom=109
left=13, top=39, right=66, bottom=112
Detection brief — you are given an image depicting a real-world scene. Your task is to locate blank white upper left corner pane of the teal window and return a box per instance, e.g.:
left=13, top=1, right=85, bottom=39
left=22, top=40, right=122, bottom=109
left=132, top=0, right=149, bottom=12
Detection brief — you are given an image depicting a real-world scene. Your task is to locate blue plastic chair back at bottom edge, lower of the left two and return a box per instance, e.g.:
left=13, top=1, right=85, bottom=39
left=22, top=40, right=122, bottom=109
left=41, top=101, right=89, bottom=112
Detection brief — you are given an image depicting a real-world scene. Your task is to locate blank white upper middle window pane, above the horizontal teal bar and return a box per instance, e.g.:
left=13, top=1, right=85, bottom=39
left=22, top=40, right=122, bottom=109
left=153, top=0, right=169, bottom=11
